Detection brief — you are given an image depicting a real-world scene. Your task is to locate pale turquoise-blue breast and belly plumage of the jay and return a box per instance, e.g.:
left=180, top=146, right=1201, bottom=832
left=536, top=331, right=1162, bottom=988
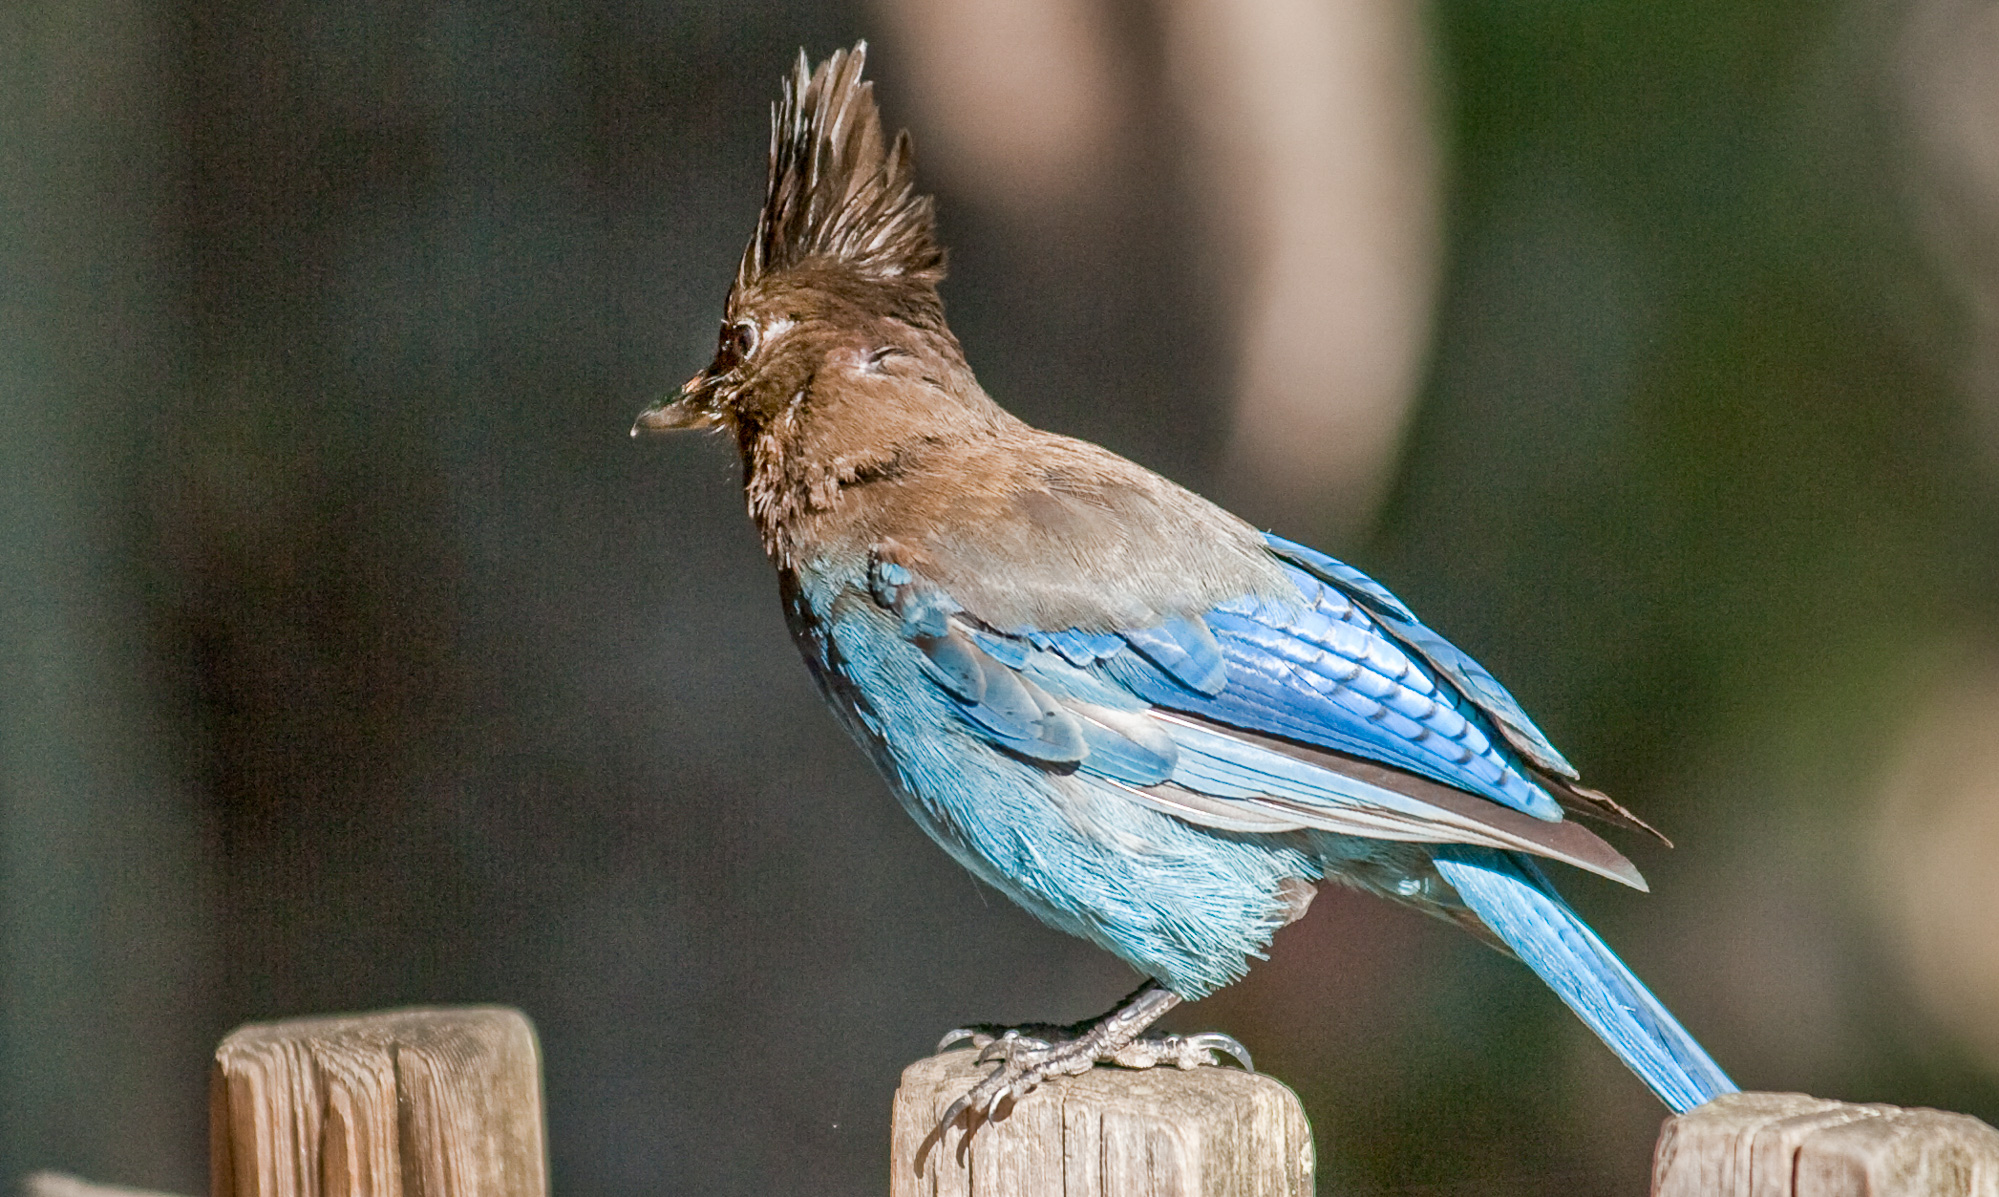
left=790, top=574, right=1321, bottom=997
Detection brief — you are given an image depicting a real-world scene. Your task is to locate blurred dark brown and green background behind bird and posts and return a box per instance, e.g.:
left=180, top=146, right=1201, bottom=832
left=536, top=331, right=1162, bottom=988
left=11, top=0, right=1999, bottom=1197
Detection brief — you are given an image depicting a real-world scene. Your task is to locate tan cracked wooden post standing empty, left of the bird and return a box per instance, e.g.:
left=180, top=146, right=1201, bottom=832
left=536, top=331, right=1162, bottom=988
left=210, top=1007, right=548, bottom=1197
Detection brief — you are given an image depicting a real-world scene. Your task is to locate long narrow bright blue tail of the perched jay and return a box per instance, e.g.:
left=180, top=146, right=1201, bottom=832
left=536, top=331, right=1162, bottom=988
left=1435, top=845, right=1735, bottom=1113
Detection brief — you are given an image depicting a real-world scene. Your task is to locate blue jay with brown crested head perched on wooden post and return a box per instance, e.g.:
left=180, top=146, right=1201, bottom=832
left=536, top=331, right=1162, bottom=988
left=632, top=42, right=1735, bottom=1123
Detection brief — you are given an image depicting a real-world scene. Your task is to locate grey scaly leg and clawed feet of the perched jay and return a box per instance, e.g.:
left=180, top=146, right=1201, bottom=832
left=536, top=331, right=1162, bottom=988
left=938, top=981, right=1253, bottom=1129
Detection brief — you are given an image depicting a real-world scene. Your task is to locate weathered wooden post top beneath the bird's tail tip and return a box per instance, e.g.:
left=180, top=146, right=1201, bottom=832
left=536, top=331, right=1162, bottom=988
left=1651, top=1093, right=1999, bottom=1197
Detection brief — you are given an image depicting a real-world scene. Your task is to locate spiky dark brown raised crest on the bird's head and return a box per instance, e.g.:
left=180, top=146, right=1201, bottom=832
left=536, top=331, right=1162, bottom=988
left=736, top=42, right=944, bottom=288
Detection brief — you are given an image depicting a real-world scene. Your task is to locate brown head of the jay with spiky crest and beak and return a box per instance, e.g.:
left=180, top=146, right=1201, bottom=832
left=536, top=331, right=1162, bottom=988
left=632, top=42, right=956, bottom=447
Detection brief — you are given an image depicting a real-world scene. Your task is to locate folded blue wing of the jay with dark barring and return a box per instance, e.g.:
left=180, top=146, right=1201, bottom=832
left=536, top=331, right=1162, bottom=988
left=870, top=538, right=1643, bottom=887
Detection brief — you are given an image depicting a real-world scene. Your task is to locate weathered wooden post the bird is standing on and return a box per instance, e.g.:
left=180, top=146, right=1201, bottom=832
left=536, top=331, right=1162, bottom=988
left=888, top=1049, right=1313, bottom=1197
